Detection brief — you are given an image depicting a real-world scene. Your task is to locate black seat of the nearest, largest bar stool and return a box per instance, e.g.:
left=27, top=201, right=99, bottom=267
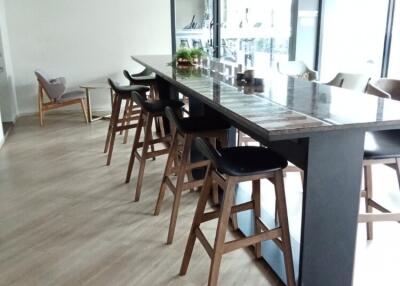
left=196, top=138, right=288, bottom=176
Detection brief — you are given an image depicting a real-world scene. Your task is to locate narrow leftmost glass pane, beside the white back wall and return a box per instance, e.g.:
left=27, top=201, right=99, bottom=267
left=175, top=0, right=215, bottom=55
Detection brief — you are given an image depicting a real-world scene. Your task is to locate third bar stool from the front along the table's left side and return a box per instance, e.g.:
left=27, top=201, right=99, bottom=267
left=125, top=92, right=183, bottom=202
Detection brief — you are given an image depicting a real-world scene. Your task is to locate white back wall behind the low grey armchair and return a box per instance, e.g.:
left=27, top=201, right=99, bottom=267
left=5, top=0, right=171, bottom=114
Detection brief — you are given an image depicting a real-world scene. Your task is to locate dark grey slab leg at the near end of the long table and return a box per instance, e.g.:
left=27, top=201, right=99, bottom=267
left=299, top=130, right=364, bottom=286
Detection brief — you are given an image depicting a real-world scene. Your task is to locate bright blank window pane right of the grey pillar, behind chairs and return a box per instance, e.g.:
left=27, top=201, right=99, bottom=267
left=320, top=0, right=389, bottom=81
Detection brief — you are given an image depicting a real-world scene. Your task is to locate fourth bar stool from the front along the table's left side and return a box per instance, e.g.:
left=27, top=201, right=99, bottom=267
left=104, top=79, right=149, bottom=166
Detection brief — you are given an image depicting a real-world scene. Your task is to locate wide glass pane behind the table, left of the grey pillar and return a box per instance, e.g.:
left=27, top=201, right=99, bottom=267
left=220, top=0, right=292, bottom=71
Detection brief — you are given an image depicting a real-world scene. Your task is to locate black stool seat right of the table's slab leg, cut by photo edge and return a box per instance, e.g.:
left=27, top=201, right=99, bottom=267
left=364, top=130, right=400, bottom=160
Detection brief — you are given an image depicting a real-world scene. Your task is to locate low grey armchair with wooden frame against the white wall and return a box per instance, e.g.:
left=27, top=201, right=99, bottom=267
left=35, top=70, right=88, bottom=126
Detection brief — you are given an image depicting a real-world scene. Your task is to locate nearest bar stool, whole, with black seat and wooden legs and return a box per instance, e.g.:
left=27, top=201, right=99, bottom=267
left=180, top=138, right=295, bottom=286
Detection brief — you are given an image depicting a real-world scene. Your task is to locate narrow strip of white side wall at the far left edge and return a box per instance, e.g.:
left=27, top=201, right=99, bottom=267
left=0, top=0, right=18, bottom=122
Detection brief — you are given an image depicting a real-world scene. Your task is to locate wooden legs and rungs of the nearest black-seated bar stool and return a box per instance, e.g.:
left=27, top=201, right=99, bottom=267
left=179, top=164, right=296, bottom=286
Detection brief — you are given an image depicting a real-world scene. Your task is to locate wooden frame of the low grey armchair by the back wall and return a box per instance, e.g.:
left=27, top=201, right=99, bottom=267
left=38, top=81, right=89, bottom=126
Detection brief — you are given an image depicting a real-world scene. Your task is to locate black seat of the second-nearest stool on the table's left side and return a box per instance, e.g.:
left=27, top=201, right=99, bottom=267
left=165, top=107, right=231, bottom=134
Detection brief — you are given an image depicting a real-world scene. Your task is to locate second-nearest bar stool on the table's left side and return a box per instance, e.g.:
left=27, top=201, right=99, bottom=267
left=154, top=107, right=231, bottom=244
